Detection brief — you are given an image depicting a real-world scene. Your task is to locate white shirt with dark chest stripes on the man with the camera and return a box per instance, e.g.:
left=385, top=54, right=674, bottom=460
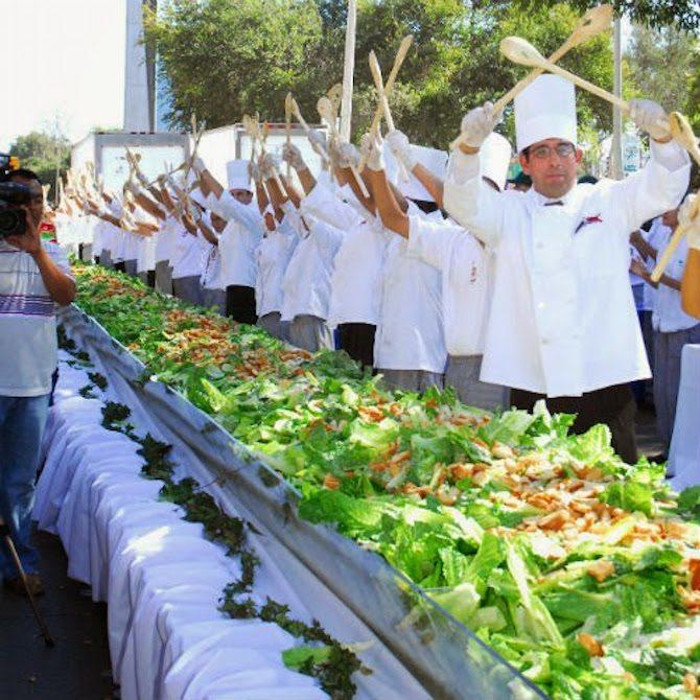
left=0, top=238, right=72, bottom=396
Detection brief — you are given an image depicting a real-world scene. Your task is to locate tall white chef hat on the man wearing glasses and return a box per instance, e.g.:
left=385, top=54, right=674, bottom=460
left=515, top=75, right=577, bottom=153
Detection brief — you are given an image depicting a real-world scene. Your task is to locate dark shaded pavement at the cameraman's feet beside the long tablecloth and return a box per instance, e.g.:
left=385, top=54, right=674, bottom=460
left=0, top=533, right=113, bottom=700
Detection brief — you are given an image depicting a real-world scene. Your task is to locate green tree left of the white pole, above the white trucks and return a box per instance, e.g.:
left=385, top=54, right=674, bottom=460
left=145, top=0, right=322, bottom=128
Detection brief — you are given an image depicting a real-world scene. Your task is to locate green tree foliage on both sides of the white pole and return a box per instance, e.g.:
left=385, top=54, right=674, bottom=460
left=146, top=0, right=612, bottom=148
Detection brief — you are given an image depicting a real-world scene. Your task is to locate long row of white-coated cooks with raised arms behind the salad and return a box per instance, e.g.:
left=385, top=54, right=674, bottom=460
left=55, top=75, right=700, bottom=462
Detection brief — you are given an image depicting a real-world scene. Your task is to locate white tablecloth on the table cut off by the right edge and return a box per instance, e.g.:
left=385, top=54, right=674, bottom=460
left=668, top=345, right=700, bottom=490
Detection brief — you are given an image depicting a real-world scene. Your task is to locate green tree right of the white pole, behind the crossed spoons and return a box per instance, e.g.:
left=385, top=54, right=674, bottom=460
left=350, top=0, right=612, bottom=148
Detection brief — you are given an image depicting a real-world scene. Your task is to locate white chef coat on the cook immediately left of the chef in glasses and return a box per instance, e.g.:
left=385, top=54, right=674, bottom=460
left=408, top=216, right=492, bottom=356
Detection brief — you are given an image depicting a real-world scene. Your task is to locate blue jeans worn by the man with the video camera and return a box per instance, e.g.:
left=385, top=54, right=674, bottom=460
left=0, top=394, right=49, bottom=578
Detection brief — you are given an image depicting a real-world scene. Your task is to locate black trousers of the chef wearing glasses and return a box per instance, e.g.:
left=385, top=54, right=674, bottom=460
left=510, top=384, right=638, bottom=464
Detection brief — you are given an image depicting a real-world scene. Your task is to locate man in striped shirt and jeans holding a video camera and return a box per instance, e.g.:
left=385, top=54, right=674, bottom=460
left=0, top=169, right=76, bottom=594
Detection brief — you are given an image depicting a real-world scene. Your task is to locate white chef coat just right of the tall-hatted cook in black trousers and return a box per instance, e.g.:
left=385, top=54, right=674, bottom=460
left=255, top=216, right=299, bottom=317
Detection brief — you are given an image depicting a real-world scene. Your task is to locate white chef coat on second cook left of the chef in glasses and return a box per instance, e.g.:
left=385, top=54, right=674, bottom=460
left=374, top=203, right=447, bottom=374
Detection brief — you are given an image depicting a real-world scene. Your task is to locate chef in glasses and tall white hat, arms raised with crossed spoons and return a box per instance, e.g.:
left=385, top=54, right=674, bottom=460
left=445, top=75, right=690, bottom=462
